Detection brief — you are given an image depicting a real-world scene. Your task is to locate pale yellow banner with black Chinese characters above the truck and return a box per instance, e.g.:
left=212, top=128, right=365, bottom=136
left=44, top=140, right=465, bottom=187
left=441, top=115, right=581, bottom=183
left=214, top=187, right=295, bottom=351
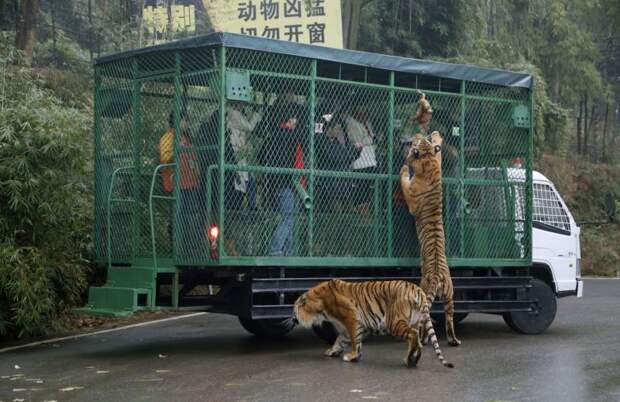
left=203, top=0, right=342, bottom=48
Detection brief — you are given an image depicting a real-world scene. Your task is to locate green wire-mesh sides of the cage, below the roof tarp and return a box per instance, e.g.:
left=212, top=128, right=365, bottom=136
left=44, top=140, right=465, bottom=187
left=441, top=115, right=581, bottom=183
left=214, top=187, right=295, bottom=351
left=95, top=41, right=532, bottom=265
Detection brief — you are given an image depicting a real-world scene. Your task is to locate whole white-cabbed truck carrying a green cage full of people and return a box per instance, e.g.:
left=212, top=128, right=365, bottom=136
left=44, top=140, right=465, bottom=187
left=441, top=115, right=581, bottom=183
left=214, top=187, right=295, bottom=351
left=79, top=33, right=583, bottom=338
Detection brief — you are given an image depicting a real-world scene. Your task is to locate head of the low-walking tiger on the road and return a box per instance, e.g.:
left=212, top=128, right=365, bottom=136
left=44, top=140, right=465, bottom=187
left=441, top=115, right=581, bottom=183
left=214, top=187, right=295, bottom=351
left=293, top=279, right=341, bottom=328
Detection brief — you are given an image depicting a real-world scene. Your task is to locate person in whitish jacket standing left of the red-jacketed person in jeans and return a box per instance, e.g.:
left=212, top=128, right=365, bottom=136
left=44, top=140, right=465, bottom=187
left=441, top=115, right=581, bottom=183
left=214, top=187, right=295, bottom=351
left=226, top=101, right=262, bottom=209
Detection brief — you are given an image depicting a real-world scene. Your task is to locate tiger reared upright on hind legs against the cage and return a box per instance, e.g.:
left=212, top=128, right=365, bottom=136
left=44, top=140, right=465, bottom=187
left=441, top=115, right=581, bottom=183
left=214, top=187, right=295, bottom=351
left=400, top=131, right=461, bottom=346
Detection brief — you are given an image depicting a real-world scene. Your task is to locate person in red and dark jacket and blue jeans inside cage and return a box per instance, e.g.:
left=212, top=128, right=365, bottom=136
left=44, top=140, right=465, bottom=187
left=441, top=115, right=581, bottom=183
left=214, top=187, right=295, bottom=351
left=259, top=102, right=306, bottom=256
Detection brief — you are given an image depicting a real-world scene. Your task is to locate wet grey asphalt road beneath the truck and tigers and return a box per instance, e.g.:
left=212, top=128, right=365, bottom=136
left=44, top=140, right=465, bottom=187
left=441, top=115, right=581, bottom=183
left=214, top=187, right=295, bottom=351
left=0, top=280, right=620, bottom=402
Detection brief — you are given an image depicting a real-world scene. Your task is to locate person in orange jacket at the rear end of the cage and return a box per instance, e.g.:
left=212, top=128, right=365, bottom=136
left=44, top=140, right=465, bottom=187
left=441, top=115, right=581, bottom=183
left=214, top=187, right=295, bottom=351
left=159, top=111, right=201, bottom=252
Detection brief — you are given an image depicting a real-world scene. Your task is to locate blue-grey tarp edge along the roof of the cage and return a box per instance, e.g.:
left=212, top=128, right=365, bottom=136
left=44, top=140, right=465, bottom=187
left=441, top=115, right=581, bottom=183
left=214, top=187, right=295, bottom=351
left=95, top=32, right=533, bottom=88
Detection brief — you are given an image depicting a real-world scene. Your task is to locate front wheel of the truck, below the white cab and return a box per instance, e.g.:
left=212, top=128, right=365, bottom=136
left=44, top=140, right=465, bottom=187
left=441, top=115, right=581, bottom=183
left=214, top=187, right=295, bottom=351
left=503, top=279, right=557, bottom=335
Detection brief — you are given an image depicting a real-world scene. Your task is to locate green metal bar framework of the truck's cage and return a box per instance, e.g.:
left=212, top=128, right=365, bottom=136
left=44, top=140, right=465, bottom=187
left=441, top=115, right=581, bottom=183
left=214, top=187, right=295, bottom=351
left=94, top=34, right=534, bottom=274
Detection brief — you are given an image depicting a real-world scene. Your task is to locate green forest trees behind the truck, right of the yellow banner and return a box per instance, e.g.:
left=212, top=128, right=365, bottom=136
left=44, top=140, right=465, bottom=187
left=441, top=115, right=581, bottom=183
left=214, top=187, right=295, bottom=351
left=359, top=0, right=620, bottom=160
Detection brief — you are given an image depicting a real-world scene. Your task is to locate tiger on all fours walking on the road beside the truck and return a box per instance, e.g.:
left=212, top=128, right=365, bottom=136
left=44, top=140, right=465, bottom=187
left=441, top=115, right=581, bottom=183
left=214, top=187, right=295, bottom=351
left=292, top=279, right=453, bottom=367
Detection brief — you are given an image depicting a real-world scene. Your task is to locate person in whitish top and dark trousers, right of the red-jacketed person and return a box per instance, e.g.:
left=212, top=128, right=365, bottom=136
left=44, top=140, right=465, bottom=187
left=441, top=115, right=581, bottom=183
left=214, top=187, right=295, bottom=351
left=345, top=100, right=377, bottom=214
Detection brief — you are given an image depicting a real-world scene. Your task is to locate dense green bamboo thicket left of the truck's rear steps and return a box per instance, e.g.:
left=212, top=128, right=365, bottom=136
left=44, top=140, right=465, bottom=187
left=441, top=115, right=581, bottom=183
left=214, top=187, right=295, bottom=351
left=0, top=40, right=92, bottom=336
